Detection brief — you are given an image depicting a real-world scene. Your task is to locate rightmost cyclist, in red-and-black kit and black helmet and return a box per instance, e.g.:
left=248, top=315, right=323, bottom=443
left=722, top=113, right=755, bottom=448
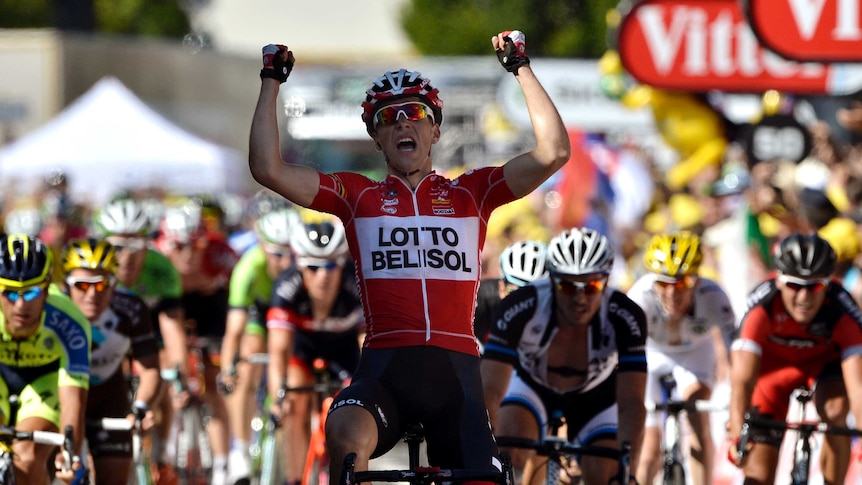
left=728, top=233, right=862, bottom=484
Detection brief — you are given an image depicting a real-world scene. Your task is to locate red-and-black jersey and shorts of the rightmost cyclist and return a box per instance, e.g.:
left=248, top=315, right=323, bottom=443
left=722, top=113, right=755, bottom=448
left=732, top=278, right=862, bottom=419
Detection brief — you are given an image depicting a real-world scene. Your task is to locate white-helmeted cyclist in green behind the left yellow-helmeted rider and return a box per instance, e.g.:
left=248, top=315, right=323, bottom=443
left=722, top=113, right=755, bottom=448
left=95, top=199, right=189, bottom=485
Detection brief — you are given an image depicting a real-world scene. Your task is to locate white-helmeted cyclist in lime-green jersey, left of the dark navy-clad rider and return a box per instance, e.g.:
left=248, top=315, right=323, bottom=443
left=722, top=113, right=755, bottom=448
left=220, top=207, right=301, bottom=484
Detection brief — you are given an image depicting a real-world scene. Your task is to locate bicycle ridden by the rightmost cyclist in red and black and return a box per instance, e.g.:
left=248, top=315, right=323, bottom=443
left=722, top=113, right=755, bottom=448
left=737, top=386, right=862, bottom=485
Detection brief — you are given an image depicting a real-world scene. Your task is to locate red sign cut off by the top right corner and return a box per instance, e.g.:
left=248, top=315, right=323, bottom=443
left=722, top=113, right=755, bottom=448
left=743, top=0, right=862, bottom=62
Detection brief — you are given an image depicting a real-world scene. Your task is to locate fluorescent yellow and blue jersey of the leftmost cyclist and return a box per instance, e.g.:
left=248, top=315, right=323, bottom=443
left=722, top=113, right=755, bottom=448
left=0, top=285, right=90, bottom=389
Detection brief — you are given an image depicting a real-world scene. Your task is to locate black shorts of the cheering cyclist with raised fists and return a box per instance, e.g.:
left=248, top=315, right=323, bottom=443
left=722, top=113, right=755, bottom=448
left=329, top=346, right=497, bottom=471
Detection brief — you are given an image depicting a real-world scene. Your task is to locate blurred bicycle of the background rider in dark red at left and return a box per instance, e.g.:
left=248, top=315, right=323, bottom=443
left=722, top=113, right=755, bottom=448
left=161, top=364, right=212, bottom=485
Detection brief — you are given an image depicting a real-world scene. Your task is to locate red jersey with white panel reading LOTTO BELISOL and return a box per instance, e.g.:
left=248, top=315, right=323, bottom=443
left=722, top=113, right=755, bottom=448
left=311, top=167, right=515, bottom=355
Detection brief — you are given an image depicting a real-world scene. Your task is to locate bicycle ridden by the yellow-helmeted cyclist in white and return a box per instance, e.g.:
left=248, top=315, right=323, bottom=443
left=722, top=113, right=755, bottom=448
left=646, top=374, right=726, bottom=485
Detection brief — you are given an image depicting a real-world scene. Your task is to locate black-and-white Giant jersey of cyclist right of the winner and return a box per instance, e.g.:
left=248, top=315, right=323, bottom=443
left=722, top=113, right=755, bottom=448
left=483, top=278, right=647, bottom=394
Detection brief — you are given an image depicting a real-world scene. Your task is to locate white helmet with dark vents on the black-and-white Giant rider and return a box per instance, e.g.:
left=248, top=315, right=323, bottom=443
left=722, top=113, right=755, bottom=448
left=548, top=227, right=614, bottom=276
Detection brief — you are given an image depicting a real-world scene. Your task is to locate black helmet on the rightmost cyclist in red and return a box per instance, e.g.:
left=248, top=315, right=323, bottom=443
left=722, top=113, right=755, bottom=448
left=773, top=233, right=836, bottom=278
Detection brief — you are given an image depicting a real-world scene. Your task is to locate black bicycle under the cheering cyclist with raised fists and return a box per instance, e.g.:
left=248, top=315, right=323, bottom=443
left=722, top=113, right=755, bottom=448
left=339, top=423, right=515, bottom=485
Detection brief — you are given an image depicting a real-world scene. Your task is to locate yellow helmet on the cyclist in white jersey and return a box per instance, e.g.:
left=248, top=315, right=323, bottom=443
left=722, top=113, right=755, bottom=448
left=644, top=231, right=703, bottom=276
